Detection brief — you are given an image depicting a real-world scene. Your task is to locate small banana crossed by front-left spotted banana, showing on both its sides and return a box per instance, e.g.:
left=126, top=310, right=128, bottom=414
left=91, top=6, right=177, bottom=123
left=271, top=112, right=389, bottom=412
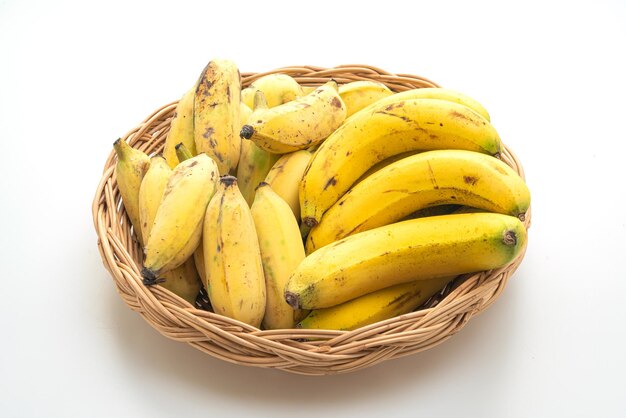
left=139, top=156, right=201, bottom=305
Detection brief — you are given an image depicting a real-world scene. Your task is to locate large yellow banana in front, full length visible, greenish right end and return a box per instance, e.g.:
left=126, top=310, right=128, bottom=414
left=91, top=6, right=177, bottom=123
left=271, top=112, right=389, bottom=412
left=285, top=213, right=526, bottom=309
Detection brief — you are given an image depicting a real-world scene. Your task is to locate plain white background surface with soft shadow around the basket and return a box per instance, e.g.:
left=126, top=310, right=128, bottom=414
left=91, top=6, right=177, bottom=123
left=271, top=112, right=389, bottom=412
left=0, top=0, right=626, bottom=417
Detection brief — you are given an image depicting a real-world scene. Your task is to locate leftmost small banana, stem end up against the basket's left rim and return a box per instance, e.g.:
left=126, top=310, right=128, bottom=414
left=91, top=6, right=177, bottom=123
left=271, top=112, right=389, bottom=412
left=113, top=138, right=150, bottom=245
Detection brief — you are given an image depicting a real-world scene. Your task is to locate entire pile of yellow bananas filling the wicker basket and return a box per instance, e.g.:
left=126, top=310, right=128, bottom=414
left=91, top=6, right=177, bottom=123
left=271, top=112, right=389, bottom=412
left=114, top=59, right=530, bottom=330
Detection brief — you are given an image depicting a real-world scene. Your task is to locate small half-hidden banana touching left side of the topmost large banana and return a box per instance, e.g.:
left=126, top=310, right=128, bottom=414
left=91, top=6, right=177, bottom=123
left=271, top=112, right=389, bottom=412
left=265, top=150, right=313, bottom=222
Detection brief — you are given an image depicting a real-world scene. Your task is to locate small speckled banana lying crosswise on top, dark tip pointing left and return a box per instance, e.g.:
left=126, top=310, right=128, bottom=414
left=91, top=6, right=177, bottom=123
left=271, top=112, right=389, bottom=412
left=240, top=81, right=346, bottom=154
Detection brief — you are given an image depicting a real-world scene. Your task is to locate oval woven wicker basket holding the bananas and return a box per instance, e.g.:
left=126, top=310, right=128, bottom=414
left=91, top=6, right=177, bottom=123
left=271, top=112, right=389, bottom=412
left=92, top=65, right=531, bottom=375
